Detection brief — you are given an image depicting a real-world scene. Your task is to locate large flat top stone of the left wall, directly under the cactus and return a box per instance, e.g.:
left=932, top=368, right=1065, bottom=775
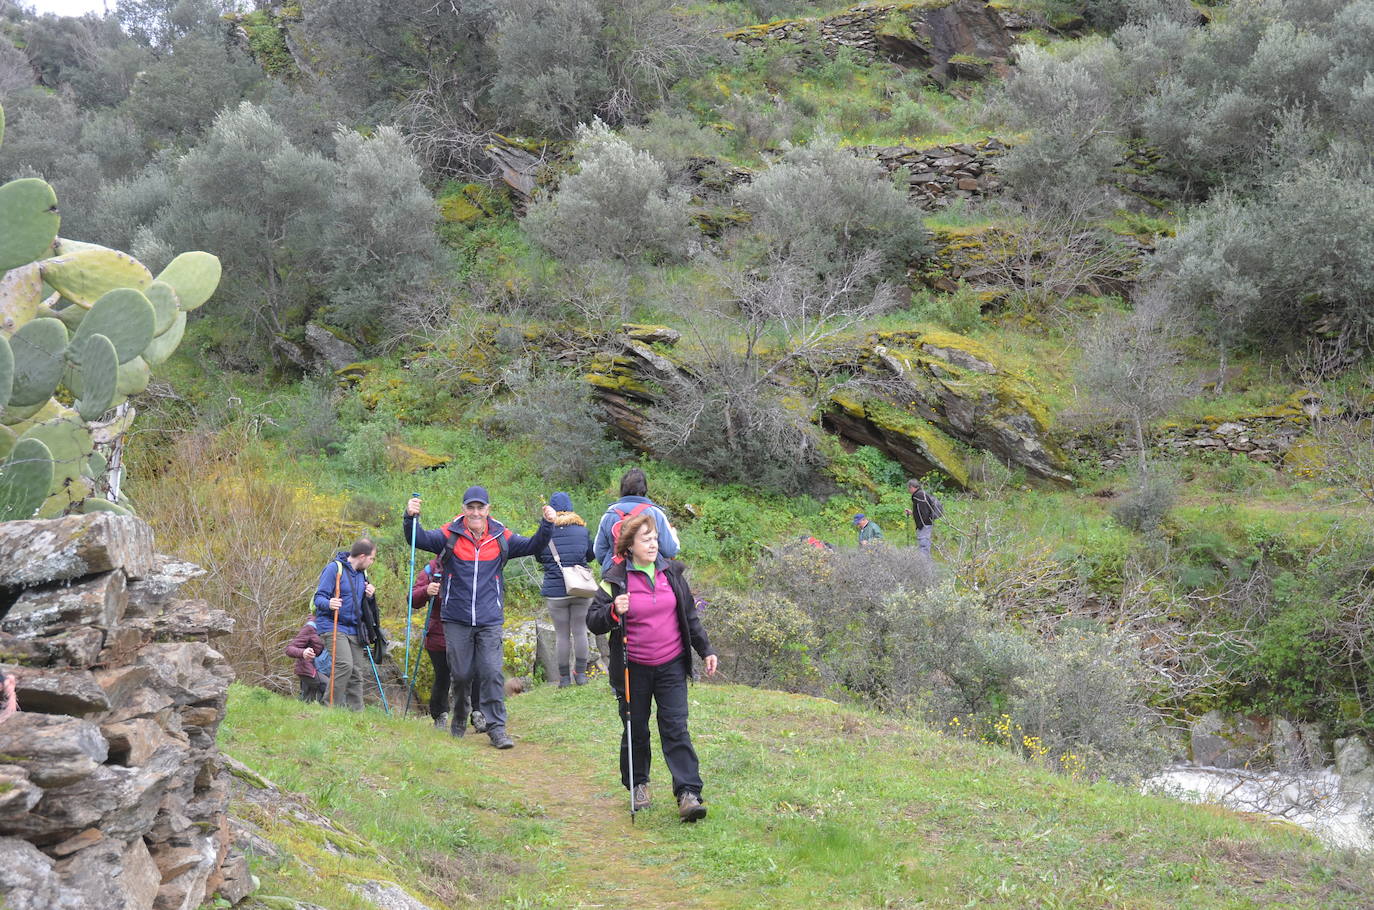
left=0, top=511, right=155, bottom=588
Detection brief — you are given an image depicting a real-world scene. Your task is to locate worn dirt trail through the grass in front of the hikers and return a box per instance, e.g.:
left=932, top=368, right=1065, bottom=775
left=464, top=737, right=717, bottom=910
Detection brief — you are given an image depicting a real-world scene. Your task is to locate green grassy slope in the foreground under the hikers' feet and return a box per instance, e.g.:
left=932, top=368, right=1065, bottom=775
left=220, top=685, right=1374, bottom=910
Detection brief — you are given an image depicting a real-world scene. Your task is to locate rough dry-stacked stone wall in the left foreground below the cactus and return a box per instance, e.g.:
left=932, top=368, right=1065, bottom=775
left=0, top=513, right=251, bottom=910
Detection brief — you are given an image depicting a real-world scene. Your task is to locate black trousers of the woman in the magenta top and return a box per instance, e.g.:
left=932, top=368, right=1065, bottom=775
left=616, top=657, right=701, bottom=797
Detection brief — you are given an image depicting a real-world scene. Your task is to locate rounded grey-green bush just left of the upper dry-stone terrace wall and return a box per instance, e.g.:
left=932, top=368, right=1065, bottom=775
left=735, top=136, right=930, bottom=274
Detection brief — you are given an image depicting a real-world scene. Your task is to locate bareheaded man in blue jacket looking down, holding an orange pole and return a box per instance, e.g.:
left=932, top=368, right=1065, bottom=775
left=315, top=537, right=376, bottom=711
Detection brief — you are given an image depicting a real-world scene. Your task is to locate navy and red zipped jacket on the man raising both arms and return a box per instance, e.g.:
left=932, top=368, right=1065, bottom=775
left=401, top=515, right=554, bottom=625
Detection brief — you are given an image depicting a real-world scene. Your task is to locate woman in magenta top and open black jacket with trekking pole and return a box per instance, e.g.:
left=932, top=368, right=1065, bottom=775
left=587, top=514, right=716, bottom=822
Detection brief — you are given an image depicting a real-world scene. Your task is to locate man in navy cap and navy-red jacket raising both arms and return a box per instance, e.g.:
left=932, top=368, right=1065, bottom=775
left=401, top=487, right=555, bottom=749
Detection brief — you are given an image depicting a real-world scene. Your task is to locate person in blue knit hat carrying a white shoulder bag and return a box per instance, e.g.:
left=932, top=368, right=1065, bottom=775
left=536, top=493, right=592, bottom=689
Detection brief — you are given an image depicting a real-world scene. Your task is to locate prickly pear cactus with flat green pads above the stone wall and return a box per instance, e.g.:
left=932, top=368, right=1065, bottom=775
left=0, top=99, right=220, bottom=521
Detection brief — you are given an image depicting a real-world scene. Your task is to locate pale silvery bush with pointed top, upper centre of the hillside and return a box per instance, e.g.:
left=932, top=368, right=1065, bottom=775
left=525, top=121, right=695, bottom=263
